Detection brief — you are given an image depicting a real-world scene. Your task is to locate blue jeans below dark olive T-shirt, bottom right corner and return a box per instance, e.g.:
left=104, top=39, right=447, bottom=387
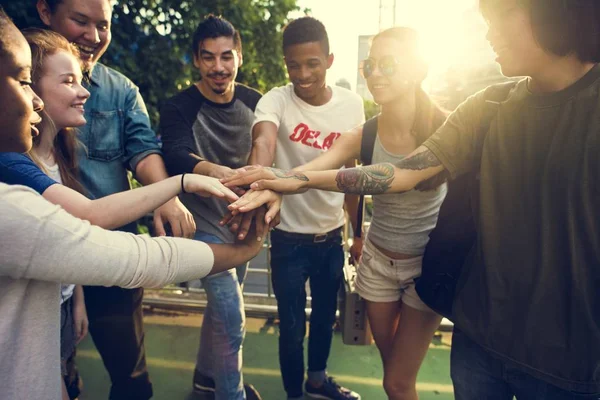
left=450, top=328, right=600, bottom=400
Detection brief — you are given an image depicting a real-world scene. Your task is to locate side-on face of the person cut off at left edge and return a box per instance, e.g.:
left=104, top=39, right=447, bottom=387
left=0, top=26, right=44, bottom=153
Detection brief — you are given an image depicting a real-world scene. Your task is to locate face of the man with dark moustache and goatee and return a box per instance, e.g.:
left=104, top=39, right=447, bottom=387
left=194, top=36, right=242, bottom=102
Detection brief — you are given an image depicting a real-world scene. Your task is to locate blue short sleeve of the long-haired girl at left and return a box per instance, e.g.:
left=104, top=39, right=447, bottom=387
left=0, top=153, right=57, bottom=194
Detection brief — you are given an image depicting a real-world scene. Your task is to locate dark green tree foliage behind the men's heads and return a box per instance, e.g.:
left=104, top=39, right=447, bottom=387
left=0, top=0, right=298, bottom=123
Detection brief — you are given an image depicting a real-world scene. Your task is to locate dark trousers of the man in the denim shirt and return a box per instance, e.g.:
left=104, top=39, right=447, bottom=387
left=83, top=286, right=152, bottom=400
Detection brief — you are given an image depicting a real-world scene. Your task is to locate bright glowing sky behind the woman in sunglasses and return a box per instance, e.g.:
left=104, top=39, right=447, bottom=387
left=294, top=0, right=493, bottom=88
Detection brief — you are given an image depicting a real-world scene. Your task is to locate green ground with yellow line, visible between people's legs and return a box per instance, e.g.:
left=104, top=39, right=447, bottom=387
left=77, top=316, right=454, bottom=400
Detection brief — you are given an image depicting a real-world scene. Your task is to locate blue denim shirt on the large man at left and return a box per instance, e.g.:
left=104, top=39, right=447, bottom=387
left=79, top=63, right=160, bottom=230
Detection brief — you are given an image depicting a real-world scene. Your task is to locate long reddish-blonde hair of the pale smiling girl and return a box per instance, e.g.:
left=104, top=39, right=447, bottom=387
left=23, top=28, right=84, bottom=193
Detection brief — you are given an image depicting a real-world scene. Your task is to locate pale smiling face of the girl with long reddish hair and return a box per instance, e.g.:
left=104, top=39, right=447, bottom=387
left=35, top=51, right=90, bottom=130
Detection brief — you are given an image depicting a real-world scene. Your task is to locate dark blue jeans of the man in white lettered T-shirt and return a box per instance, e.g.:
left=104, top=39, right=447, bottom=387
left=271, top=230, right=344, bottom=397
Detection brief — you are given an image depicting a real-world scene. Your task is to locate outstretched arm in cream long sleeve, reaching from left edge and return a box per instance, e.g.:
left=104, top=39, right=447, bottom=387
left=0, top=184, right=263, bottom=288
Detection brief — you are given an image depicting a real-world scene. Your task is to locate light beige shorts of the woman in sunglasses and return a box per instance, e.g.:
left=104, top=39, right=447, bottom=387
left=356, top=238, right=433, bottom=312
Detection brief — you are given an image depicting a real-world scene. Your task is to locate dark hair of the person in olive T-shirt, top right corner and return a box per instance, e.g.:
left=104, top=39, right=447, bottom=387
left=479, top=0, right=600, bottom=63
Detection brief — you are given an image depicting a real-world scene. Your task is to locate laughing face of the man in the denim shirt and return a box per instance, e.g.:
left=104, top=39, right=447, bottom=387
left=37, top=0, right=112, bottom=70
